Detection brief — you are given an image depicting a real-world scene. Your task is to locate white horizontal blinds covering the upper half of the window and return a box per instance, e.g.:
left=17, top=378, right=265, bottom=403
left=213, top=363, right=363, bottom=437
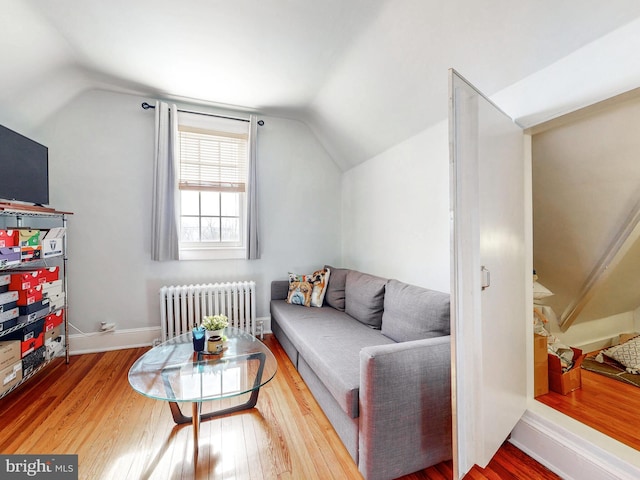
left=178, top=113, right=249, bottom=192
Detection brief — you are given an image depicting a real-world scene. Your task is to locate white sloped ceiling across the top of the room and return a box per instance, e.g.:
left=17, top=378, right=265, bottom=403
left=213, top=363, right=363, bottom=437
left=0, top=0, right=640, bottom=169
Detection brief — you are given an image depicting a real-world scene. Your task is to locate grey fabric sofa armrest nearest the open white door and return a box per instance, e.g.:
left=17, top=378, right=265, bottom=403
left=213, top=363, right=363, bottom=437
left=358, top=335, right=452, bottom=480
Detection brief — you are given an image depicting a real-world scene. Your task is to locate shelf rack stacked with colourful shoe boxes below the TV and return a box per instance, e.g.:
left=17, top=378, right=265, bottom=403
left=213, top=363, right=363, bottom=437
left=0, top=203, right=70, bottom=397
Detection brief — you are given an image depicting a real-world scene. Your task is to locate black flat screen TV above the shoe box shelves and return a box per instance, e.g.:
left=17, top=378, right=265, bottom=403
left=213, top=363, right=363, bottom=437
left=0, top=125, right=49, bottom=205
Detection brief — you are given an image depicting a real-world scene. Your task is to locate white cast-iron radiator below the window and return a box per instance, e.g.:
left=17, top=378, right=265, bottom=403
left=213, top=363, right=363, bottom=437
left=160, top=282, right=263, bottom=342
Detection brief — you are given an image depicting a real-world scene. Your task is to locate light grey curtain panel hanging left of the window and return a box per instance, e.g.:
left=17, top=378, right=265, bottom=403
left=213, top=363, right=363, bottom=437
left=151, top=102, right=179, bottom=262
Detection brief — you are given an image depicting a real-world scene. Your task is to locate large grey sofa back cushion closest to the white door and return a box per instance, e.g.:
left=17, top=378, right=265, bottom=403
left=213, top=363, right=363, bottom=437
left=382, top=280, right=450, bottom=342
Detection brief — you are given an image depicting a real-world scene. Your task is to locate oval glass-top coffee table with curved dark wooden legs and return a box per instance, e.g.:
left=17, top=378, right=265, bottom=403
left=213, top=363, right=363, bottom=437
left=129, top=327, right=278, bottom=459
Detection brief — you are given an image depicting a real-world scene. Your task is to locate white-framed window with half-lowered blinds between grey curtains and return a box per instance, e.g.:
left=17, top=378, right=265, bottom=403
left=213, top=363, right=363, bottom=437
left=178, top=112, right=249, bottom=259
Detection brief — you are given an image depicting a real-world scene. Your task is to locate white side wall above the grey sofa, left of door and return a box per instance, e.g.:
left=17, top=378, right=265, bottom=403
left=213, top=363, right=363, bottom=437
left=342, top=121, right=450, bottom=292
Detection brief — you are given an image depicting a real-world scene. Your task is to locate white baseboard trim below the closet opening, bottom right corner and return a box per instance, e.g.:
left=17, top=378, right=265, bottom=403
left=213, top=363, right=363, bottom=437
left=509, top=410, right=640, bottom=480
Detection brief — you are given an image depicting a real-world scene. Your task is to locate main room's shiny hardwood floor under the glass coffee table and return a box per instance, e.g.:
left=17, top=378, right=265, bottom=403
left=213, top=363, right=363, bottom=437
left=0, top=335, right=559, bottom=480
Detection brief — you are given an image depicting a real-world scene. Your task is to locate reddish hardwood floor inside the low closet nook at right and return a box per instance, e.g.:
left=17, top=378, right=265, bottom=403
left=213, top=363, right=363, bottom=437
left=536, top=369, right=640, bottom=450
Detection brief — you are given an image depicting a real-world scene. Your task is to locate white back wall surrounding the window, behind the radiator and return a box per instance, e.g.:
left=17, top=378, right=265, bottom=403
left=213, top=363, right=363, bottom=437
left=38, top=90, right=341, bottom=351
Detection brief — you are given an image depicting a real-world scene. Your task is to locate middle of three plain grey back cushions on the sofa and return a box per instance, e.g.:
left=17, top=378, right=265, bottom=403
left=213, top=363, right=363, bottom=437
left=344, top=270, right=387, bottom=329
